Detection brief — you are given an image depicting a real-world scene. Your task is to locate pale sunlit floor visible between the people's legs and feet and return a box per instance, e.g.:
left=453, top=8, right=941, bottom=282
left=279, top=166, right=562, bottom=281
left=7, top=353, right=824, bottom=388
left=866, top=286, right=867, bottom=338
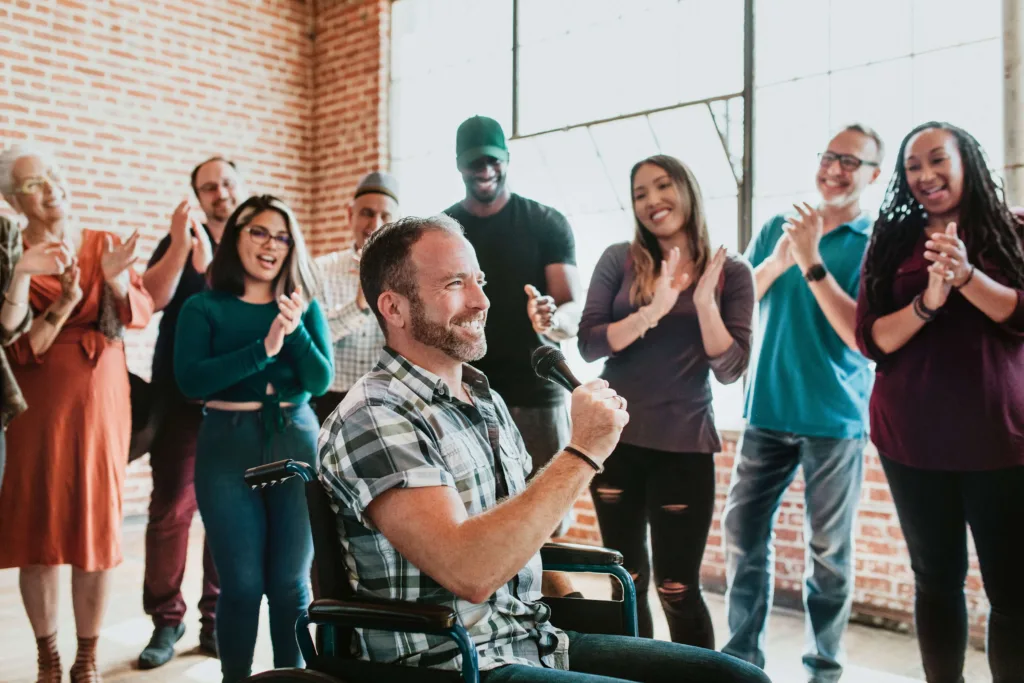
left=0, top=521, right=991, bottom=683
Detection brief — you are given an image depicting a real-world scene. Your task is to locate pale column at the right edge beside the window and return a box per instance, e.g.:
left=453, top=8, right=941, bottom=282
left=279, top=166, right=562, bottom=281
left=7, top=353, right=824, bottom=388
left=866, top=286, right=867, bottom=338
left=1002, top=0, right=1024, bottom=206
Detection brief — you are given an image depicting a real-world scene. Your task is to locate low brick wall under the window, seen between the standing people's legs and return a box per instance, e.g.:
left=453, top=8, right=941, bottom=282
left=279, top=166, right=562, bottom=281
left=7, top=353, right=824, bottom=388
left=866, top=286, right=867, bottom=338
left=566, top=434, right=988, bottom=644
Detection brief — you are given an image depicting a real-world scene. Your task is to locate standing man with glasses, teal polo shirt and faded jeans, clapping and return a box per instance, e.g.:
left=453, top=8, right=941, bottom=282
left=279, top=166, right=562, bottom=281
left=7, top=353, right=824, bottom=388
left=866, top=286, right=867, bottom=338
left=722, top=124, right=884, bottom=683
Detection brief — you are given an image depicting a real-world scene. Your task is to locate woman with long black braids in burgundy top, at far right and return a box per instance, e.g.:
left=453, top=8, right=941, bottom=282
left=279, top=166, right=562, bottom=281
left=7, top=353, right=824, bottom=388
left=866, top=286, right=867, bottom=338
left=857, top=122, right=1024, bottom=683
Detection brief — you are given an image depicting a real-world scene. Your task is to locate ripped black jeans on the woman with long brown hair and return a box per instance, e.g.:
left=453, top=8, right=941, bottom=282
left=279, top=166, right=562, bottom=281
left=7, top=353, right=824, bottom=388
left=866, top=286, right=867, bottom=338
left=590, top=443, right=715, bottom=649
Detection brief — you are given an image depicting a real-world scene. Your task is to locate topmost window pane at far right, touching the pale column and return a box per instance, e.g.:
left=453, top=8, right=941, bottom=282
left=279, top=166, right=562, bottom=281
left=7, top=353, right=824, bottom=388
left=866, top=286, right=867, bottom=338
left=913, top=0, right=1002, bottom=53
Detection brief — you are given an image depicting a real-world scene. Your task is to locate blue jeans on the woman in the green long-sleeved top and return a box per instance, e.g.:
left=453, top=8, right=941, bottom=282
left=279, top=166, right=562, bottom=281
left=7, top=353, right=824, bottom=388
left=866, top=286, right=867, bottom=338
left=196, top=404, right=319, bottom=683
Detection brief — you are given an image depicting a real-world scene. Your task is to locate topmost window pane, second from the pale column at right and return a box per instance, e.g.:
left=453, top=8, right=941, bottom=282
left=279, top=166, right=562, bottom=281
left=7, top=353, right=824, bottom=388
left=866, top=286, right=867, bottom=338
left=828, top=0, right=912, bottom=71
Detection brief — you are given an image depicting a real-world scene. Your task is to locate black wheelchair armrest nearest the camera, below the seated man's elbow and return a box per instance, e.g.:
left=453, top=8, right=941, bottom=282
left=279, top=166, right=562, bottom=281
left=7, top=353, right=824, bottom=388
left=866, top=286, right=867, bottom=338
left=309, top=598, right=458, bottom=633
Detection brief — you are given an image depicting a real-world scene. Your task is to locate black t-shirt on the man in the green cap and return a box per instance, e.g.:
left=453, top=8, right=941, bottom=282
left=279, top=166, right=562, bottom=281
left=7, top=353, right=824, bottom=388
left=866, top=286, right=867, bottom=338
left=444, top=195, right=575, bottom=407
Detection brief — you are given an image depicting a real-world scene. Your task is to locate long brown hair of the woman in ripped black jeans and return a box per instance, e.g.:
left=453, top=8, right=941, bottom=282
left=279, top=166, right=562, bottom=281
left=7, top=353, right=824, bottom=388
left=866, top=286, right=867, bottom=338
left=630, top=155, right=711, bottom=306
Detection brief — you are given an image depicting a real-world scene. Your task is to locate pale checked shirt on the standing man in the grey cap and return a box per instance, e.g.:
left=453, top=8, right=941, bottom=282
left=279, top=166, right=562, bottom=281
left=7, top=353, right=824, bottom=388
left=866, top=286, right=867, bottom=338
left=316, top=249, right=384, bottom=392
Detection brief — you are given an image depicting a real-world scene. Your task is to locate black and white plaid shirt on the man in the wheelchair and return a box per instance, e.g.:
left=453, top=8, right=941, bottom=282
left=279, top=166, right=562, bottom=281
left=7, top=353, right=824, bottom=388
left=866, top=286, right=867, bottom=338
left=318, top=347, right=568, bottom=671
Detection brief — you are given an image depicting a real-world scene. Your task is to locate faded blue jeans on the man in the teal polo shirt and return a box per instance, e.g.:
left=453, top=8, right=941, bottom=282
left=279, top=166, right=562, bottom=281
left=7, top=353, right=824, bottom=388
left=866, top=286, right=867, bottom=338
left=722, top=427, right=865, bottom=682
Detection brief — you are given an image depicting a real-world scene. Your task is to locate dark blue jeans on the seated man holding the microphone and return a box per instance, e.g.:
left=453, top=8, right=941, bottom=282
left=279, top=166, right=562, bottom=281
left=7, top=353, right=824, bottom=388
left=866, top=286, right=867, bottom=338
left=327, top=631, right=771, bottom=683
